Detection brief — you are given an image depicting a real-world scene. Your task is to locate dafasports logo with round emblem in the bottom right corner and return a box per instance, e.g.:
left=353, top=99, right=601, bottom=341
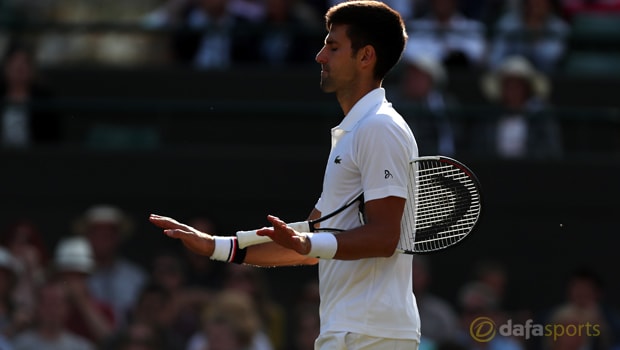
left=469, top=317, right=601, bottom=343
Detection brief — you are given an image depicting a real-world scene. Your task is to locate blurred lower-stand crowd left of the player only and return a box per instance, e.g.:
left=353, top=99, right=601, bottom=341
left=0, top=205, right=319, bottom=350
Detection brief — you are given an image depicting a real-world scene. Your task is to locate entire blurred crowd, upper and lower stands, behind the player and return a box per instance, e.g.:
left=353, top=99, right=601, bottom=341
left=0, top=0, right=620, bottom=350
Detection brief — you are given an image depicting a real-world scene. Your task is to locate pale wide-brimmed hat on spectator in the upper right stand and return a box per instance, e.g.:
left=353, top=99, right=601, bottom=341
left=482, top=56, right=551, bottom=100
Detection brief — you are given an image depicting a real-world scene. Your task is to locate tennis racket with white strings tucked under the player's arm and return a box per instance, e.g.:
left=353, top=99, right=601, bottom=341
left=237, top=156, right=482, bottom=254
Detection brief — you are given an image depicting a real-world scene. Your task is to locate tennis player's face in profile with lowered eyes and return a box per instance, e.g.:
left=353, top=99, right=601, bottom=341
left=316, top=24, right=358, bottom=92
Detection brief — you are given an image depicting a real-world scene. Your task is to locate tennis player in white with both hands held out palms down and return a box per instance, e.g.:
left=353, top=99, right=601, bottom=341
left=150, top=1, right=420, bottom=350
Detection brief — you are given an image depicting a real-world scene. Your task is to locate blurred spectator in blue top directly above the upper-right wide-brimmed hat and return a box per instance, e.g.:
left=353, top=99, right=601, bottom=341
left=489, top=0, right=569, bottom=73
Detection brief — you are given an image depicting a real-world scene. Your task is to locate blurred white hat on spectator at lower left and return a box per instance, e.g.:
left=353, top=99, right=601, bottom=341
left=54, top=236, right=95, bottom=273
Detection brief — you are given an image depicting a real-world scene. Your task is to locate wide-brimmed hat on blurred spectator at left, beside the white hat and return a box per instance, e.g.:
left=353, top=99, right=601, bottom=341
left=74, top=204, right=133, bottom=237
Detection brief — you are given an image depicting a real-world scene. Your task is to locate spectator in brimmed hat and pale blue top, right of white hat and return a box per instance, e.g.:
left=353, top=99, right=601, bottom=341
left=75, top=205, right=148, bottom=326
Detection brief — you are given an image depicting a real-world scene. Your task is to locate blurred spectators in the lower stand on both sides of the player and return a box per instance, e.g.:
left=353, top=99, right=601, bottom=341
left=0, top=205, right=620, bottom=350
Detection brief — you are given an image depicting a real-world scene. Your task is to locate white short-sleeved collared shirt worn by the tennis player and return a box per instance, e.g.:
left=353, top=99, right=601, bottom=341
left=316, top=88, right=420, bottom=341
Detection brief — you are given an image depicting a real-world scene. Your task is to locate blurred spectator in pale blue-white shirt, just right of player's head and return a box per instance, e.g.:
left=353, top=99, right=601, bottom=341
left=407, top=0, right=487, bottom=69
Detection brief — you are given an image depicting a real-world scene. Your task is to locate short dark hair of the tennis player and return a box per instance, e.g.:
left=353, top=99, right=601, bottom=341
left=325, top=1, right=407, bottom=80
